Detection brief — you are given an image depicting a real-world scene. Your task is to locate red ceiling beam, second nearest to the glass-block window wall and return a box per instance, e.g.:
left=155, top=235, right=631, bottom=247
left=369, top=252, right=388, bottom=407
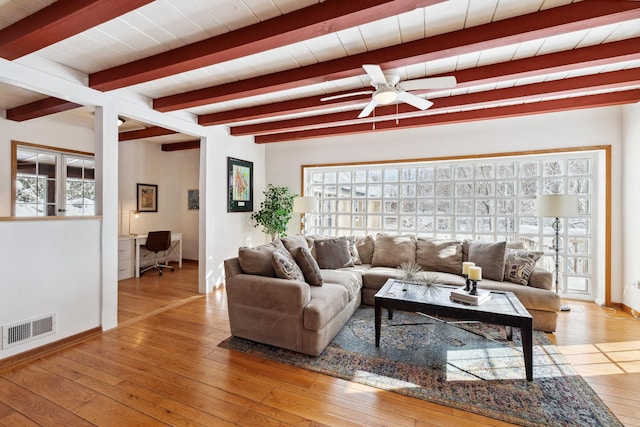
left=230, top=69, right=640, bottom=136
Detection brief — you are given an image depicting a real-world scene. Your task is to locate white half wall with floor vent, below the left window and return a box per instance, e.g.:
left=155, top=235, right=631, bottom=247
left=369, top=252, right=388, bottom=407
left=0, top=219, right=101, bottom=359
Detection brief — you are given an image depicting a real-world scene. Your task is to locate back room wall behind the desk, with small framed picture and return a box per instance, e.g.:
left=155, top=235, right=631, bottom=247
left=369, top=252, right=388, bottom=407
left=118, top=141, right=200, bottom=260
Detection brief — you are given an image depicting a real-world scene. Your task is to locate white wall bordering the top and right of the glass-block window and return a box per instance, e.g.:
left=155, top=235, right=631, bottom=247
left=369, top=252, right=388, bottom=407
left=266, top=107, right=624, bottom=302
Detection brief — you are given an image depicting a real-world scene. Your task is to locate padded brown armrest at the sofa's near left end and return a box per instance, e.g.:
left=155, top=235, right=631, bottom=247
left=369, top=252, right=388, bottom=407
left=225, top=274, right=311, bottom=313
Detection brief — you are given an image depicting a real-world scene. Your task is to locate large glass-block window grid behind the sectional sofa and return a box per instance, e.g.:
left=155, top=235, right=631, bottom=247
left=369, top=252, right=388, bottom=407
left=304, top=150, right=599, bottom=296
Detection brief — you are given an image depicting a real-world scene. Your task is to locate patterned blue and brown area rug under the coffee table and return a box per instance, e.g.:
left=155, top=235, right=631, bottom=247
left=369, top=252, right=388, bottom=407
left=220, top=307, right=622, bottom=427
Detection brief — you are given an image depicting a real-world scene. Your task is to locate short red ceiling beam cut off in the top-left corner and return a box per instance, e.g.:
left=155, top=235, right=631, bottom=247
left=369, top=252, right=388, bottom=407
left=0, top=0, right=153, bottom=61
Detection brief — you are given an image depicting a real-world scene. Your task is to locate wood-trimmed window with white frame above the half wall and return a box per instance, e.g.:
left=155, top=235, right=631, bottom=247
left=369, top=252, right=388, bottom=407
left=12, top=141, right=95, bottom=217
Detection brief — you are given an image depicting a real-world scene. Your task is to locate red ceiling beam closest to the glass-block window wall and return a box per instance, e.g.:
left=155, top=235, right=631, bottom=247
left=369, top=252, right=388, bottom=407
left=255, top=89, right=640, bottom=144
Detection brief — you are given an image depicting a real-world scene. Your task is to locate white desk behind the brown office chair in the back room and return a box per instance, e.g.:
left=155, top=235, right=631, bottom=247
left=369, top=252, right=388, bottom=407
left=118, top=232, right=182, bottom=280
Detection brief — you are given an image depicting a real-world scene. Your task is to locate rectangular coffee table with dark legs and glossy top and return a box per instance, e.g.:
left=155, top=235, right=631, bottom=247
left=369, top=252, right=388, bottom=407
left=375, top=279, right=533, bottom=381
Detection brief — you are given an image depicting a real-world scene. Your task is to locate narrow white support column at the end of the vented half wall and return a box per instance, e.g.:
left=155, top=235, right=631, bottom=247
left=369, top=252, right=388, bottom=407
left=95, top=107, right=118, bottom=330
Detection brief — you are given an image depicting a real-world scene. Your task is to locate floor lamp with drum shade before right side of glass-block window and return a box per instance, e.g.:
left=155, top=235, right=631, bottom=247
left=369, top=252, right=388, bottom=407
left=536, top=194, right=580, bottom=311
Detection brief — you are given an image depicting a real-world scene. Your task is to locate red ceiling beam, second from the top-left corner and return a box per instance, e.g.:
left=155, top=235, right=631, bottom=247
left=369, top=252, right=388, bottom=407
left=89, top=0, right=444, bottom=91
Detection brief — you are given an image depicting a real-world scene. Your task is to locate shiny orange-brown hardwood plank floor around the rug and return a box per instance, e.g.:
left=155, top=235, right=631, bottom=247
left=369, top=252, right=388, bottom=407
left=0, top=263, right=640, bottom=427
